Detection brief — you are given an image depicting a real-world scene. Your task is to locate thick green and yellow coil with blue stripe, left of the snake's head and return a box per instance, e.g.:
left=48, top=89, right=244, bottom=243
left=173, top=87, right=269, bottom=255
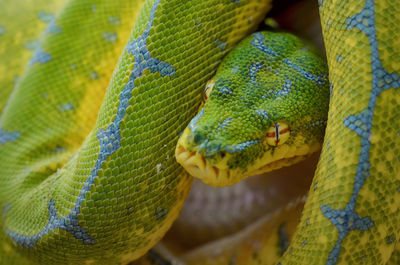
left=0, top=0, right=269, bottom=264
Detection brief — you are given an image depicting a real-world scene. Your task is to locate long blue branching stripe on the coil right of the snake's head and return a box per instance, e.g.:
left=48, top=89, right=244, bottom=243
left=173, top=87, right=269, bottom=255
left=321, top=0, right=400, bottom=265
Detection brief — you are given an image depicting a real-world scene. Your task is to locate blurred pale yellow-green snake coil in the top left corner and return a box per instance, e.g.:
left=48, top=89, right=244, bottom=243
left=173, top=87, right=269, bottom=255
left=0, top=0, right=66, bottom=113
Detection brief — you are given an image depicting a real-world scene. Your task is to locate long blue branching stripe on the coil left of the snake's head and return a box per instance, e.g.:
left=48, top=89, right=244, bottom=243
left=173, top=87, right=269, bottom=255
left=5, top=0, right=175, bottom=248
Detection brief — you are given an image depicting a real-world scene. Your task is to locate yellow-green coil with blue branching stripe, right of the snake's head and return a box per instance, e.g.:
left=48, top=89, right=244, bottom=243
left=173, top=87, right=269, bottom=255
left=179, top=0, right=400, bottom=265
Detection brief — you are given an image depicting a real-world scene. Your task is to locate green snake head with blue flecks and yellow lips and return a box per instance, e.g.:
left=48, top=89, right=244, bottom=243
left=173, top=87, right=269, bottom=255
left=175, top=32, right=329, bottom=186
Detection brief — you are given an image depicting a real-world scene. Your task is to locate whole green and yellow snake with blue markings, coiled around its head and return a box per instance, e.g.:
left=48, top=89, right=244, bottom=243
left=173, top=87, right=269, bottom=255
left=0, top=0, right=400, bottom=265
